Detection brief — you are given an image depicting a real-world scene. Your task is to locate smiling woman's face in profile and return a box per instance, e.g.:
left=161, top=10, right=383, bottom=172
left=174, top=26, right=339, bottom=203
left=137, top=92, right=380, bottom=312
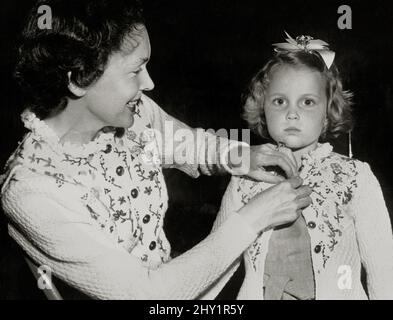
left=82, top=26, right=154, bottom=130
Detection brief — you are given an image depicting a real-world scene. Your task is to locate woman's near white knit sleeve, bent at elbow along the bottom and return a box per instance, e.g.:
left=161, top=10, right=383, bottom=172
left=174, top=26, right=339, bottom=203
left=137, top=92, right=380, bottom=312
left=2, top=181, right=256, bottom=299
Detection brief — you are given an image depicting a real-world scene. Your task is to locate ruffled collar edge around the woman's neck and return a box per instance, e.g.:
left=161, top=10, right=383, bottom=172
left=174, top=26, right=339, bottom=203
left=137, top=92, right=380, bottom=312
left=21, top=109, right=114, bottom=156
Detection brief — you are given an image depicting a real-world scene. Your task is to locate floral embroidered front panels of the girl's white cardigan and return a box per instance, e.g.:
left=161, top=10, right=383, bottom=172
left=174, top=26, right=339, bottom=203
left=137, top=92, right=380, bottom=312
left=237, top=143, right=358, bottom=273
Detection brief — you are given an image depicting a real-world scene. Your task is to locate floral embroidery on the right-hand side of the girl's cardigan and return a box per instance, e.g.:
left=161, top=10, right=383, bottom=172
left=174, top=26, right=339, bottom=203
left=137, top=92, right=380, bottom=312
left=300, top=149, right=358, bottom=268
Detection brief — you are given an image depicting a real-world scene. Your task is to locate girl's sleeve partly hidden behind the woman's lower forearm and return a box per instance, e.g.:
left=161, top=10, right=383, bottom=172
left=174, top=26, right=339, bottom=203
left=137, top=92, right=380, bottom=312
left=201, top=177, right=243, bottom=300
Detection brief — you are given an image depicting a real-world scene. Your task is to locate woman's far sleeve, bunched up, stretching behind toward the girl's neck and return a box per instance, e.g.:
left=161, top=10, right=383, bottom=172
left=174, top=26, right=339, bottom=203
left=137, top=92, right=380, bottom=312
left=143, top=96, right=249, bottom=178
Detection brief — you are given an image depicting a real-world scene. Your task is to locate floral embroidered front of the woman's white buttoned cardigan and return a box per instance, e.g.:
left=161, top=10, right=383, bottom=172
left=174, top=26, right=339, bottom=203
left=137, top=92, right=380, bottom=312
left=4, top=100, right=170, bottom=267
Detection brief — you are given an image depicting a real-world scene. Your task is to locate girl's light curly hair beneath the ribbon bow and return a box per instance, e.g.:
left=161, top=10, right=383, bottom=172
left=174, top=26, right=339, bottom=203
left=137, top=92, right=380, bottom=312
left=243, top=51, right=353, bottom=140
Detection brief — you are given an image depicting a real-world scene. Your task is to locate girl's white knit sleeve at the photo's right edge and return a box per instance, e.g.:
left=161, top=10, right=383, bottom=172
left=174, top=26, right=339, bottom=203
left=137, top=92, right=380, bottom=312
left=354, top=163, right=393, bottom=299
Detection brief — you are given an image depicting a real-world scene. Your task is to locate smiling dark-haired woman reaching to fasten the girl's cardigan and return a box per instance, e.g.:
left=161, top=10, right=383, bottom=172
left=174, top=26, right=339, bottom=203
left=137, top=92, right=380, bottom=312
left=2, top=0, right=310, bottom=299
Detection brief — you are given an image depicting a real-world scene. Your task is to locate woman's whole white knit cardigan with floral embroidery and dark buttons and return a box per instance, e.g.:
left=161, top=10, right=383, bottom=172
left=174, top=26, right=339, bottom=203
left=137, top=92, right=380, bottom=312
left=2, top=96, right=256, bottom=299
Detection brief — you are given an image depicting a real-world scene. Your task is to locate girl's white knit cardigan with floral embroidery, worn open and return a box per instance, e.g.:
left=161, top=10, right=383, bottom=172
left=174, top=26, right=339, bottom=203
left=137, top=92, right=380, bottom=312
left=203, top=144, right=393, bottom=299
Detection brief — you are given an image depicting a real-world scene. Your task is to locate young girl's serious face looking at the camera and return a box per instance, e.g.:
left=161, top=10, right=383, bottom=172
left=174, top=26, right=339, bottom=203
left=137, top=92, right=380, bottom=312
left=264, top=66, right=327, bottom=153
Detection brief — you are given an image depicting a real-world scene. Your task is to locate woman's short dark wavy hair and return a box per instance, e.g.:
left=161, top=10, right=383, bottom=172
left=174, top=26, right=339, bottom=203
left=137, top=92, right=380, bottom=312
left=14, top=0, right=144, bottom=119
